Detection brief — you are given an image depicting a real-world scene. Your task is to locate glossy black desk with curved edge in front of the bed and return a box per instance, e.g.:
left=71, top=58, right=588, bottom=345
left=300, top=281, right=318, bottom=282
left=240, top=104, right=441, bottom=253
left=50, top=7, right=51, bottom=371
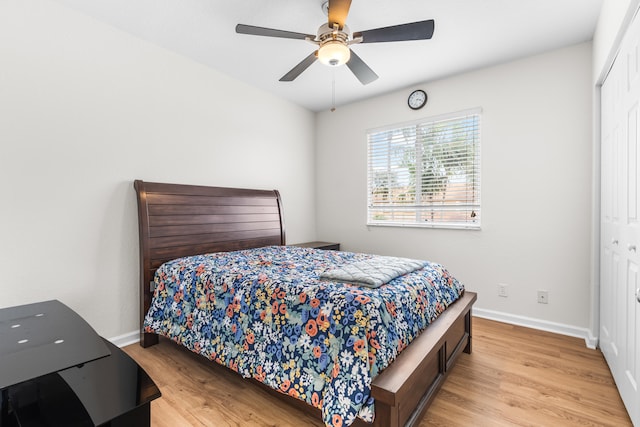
left=0, top=301, right=160, bottom=427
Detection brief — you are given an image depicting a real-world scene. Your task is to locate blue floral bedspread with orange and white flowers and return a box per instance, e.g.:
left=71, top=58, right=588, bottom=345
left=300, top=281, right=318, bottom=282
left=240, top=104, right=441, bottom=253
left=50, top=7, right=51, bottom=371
left=144, top=246, right=464, bottom=427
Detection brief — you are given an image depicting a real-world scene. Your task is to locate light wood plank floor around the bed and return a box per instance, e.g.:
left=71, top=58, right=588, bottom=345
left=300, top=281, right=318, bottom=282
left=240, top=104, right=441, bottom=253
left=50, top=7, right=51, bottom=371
left=124, top=318, right=631, bottom=427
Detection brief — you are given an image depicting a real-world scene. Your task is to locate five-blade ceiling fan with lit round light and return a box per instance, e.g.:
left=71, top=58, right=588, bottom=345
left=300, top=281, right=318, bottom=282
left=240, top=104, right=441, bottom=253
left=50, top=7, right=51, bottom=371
left=236, top=0, right=434, bottom=85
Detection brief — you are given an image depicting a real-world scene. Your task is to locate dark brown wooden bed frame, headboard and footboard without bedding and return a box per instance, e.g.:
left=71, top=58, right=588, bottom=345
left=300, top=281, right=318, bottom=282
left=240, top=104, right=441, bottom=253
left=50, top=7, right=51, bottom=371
left=134, top=180, right=476, bottom=427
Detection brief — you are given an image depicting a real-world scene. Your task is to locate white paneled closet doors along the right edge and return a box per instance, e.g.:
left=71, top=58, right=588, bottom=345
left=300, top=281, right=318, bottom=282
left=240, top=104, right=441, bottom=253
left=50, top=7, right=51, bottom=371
left=600, top=9, right=640, bottom=426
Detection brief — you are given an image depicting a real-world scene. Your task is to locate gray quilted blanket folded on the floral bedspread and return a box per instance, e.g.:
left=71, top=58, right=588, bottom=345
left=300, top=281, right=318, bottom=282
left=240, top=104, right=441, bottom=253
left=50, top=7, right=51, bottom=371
left=320, top=255, right=427, bottom=288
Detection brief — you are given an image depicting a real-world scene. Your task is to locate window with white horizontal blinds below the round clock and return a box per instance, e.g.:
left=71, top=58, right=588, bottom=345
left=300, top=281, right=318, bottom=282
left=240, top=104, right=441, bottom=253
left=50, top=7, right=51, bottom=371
left=367, top=109, right=480, bottom=228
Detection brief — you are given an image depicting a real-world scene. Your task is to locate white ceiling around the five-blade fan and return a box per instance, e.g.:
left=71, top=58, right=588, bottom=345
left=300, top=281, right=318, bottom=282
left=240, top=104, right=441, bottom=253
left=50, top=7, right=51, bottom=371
left=57, top=0, right=602, bottom=111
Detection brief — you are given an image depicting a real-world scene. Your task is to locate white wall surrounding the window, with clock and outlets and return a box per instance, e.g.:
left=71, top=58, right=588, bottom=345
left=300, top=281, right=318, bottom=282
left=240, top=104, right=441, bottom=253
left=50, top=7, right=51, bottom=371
left=316, top=43, right=592, bottom=330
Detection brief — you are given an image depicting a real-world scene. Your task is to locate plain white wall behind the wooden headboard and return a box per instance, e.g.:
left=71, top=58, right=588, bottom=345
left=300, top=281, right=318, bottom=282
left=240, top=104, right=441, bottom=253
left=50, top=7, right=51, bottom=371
left=0, top=0, right=315, bottom=338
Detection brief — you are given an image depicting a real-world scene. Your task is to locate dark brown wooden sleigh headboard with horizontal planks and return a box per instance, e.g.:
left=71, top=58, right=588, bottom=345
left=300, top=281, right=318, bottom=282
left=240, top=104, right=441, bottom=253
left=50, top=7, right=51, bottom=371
left=133, top=180, right=285, bottom=347
